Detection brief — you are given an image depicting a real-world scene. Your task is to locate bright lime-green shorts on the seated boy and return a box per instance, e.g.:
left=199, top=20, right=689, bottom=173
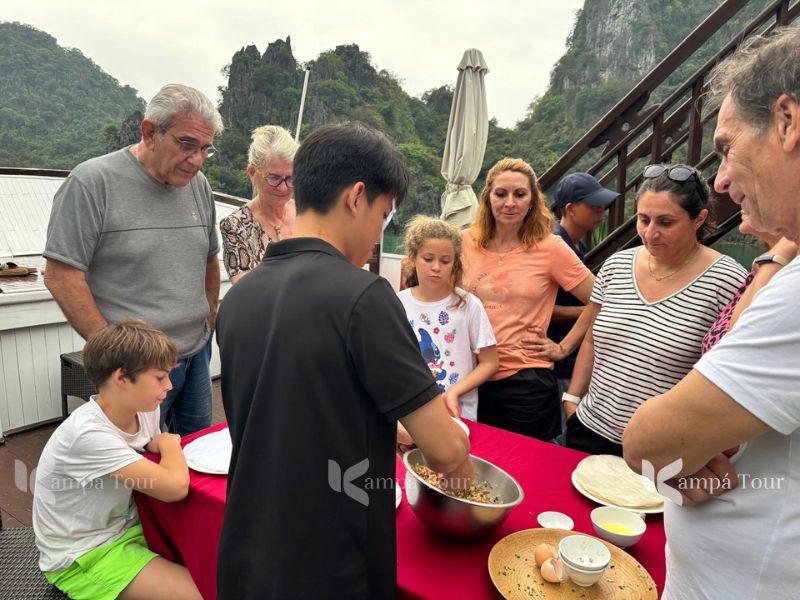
left=44, top=523, right=158, bottom=600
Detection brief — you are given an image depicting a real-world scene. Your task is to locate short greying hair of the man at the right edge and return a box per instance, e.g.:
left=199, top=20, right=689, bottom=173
left=707, top=27, right=800, bottom=134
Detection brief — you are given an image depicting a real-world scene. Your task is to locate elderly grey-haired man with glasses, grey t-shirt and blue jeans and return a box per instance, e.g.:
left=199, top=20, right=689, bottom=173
left=44, top=84, right=223, bottom=435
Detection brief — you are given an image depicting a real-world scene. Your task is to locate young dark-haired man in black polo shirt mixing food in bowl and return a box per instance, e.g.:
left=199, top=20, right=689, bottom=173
left=217, top=119, right=472, bottom=600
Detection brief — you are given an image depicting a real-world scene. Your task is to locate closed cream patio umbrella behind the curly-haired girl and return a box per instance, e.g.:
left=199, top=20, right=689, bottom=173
left=442, top=48, right=489, bottom=227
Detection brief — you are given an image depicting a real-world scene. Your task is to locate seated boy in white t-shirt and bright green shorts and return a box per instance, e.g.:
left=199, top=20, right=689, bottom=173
left=33, top=319, right=200, bottom=600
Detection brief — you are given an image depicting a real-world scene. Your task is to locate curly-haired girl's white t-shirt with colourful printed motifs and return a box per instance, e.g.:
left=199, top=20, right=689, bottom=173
left=397, top=289, right=497, bottom=421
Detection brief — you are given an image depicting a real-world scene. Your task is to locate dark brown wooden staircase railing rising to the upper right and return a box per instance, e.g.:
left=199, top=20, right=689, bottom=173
left=540, top=0, right=800, bottom=270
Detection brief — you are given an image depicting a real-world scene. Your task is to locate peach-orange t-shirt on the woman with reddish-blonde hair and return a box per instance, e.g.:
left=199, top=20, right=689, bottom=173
left=461, top=230, right=590, bottom=380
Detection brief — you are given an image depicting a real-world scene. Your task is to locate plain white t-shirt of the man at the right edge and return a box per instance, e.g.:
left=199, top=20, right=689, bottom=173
left=663, top=259, right=800, bottom=600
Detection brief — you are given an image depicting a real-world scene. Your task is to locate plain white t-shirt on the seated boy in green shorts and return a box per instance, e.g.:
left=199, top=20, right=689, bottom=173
left=33, top=396, right=160, bottom=572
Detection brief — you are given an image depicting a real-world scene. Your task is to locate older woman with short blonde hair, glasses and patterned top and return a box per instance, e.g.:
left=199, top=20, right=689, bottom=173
left=219, top=125, right=298, bottom=283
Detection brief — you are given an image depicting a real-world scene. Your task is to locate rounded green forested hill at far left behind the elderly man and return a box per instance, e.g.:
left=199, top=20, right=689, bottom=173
left=0, top=22, right=144, bottom=169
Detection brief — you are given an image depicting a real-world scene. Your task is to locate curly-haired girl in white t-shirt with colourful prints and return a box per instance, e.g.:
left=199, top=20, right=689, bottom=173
left=398, top=215, right=498, bottom=421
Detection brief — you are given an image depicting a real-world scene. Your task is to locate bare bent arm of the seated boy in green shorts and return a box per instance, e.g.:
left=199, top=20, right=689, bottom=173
left=111, top=433, right=189, bottom=502
